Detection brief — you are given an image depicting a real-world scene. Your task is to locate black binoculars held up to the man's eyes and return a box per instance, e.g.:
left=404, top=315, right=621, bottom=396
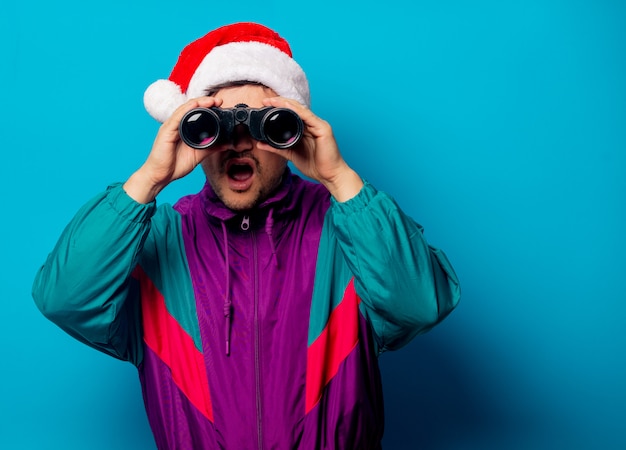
left=178, top=103, right=304, bottom=149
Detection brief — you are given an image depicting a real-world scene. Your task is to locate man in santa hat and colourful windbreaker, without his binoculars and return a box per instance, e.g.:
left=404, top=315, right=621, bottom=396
left=33, top=23, right=459, bottom=449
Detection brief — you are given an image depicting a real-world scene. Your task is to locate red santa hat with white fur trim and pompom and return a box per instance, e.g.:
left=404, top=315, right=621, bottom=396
left=144, top=22, right=310, bottom=122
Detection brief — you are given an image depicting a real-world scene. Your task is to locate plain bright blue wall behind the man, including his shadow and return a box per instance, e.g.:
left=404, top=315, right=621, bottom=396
left=0, top=0, right=626, bottom=450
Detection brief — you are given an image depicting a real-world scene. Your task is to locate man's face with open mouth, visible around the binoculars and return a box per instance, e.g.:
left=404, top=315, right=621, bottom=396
left=202, top=85, right=287, bottom=211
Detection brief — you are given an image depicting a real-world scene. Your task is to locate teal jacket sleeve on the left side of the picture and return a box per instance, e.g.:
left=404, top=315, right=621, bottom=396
left=32, top=184, right=156, bottom=364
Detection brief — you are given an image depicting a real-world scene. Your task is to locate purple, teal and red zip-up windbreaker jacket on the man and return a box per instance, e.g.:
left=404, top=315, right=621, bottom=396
left=33, top=173, right=459, bottom=450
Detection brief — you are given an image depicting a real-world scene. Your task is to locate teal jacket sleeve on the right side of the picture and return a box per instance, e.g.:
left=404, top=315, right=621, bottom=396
left=330, top=183, right=460, bottom=352
